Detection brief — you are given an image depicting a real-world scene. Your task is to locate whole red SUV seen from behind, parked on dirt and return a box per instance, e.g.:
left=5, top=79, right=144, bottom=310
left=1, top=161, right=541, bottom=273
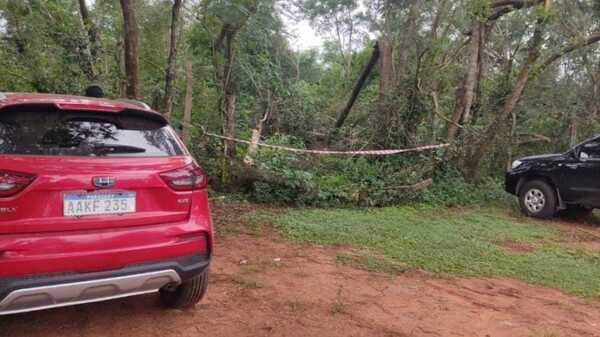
left=0, top=93, right=213, bottom=315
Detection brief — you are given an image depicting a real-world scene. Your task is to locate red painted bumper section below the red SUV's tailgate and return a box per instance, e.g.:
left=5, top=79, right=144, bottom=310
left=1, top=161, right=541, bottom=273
left=0, top=191, right=213, bottom=277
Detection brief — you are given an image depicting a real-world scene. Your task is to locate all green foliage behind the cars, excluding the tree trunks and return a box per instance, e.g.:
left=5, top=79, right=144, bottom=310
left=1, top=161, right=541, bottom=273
left=0, top=0, right=600, bottom=206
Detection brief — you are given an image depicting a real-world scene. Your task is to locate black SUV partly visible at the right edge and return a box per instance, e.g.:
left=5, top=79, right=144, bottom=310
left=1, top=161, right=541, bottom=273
left=505, top=136, right=600, bottom=218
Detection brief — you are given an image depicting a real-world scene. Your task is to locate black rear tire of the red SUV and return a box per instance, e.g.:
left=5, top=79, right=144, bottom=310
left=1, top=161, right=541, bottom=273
left=160, top=270, right=208, bottom=309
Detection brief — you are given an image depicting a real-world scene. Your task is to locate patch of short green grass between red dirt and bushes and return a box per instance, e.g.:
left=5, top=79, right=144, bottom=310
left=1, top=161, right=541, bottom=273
left=272, top=207, right=600, bottom=297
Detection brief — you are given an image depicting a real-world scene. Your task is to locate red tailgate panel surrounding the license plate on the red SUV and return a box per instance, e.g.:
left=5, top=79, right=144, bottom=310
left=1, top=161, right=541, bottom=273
left=0, top=156, right=193, bottom=234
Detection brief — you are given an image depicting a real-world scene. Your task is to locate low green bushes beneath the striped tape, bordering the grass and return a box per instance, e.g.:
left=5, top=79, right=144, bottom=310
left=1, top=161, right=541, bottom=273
left=247, top=135, right=509, bottom=207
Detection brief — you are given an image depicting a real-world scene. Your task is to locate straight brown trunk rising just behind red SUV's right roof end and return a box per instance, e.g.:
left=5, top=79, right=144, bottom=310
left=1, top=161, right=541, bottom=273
left=121, top=0, right=141, bottom=99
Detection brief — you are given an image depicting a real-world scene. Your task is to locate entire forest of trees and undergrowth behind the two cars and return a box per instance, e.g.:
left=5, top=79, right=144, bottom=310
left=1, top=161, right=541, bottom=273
left=0, top=0, right=600, bottom=206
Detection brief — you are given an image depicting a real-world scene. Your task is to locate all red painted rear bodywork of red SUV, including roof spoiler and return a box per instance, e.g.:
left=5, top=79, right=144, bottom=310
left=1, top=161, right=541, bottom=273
left=0, top=94, right=213, bottom=277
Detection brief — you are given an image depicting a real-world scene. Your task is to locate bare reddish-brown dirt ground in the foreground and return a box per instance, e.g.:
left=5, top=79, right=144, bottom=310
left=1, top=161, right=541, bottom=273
left=0, top=202, right=600, bottom=337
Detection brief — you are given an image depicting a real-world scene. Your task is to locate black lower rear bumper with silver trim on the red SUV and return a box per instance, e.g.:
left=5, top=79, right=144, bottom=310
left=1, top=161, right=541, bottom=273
left=0, top=252, right=210, bottom=316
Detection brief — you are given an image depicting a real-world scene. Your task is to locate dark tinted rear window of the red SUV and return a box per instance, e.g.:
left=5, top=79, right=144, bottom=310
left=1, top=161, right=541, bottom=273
left=0, top=107, right=184, bottom=157
